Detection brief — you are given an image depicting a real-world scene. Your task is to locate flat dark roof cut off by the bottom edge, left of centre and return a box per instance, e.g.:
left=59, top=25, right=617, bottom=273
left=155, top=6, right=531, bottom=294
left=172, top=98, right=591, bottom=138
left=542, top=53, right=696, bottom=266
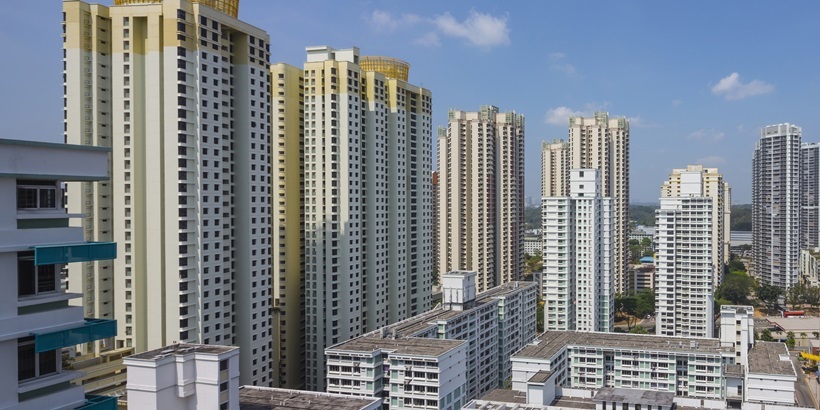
left=239, top=386, right=381, bottom=410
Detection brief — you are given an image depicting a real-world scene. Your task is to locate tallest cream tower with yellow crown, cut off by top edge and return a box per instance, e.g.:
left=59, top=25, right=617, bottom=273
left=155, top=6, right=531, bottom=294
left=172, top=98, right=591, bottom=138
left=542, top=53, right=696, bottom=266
left=63, top=0, right=273, bottom=385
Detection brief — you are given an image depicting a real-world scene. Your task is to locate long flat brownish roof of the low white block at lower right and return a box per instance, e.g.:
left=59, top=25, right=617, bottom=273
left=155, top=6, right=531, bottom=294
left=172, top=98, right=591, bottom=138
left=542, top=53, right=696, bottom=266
left=513, top=330, right=733, bottom=358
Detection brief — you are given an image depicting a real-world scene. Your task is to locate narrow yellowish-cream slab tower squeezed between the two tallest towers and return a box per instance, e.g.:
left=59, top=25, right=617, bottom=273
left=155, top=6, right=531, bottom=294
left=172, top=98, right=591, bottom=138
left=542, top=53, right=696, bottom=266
left=270, top=64, right=306, bottom=388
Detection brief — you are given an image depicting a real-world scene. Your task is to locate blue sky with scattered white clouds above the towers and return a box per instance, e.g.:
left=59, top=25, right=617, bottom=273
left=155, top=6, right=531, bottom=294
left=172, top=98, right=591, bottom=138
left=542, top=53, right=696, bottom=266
left=0, top=0, right=820, bottom=203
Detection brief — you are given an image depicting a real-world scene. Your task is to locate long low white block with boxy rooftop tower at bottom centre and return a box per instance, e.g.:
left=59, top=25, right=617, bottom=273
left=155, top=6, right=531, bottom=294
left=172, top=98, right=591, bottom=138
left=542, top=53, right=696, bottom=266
left=325, top=272, right=538, bottom=408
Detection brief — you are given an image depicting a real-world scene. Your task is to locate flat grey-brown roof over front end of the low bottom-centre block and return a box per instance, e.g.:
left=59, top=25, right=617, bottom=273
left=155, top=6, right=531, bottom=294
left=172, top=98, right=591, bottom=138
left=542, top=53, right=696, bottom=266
left=326, top=336, right=469, bottom=357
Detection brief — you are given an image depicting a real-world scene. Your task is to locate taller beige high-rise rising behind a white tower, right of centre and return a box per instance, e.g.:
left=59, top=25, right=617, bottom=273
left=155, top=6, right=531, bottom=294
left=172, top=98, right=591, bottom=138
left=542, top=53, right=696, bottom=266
left=569, top=112, right=631, bottom=293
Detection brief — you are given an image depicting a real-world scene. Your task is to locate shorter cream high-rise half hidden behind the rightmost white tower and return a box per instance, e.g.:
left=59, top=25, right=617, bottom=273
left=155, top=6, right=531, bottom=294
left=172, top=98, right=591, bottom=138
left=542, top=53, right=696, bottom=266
left=661, top=165, right=732, bottom=287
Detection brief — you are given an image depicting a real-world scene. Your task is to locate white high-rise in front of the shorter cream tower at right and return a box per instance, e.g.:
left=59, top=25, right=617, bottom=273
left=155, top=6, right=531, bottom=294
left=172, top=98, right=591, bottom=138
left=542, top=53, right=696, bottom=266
left=655, top=172, right=723, bottom=337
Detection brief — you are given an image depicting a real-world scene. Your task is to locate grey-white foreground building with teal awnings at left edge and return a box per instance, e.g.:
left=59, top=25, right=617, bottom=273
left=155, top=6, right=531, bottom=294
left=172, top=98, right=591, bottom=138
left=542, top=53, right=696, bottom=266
left=0, top=139, right=117, bottom=410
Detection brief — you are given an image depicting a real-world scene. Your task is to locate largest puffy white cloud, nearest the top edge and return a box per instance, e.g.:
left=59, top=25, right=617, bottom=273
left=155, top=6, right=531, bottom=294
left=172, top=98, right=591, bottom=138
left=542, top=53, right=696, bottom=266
left=434, top=10, right=510, bottom=48
